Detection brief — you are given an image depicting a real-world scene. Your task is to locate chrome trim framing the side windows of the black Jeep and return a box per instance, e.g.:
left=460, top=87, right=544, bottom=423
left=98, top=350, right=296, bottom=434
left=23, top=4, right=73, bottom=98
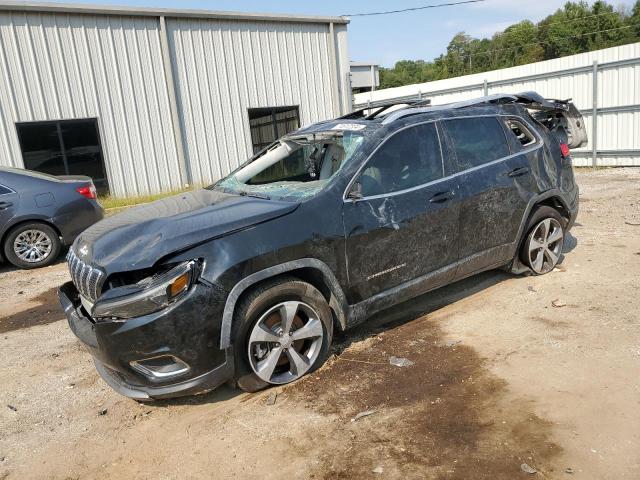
left=342, top=114, right=543, bottom=203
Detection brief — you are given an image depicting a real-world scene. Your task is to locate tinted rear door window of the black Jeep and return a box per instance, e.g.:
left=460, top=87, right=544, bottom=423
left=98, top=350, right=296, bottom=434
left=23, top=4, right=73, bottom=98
left=442, top=117, right=510, bottom=171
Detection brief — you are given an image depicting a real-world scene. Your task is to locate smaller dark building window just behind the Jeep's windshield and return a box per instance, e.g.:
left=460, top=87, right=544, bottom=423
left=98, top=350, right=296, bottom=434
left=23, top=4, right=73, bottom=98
left=249, top=107, right=300, bottom=153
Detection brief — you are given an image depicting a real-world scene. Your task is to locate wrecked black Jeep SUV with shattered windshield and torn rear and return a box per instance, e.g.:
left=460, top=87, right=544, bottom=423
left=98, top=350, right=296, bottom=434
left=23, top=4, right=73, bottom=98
left=59, top=93, right=586, bottom=400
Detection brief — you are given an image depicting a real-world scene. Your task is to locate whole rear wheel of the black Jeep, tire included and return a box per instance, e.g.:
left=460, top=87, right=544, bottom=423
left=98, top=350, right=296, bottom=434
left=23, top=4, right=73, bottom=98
left=520, top=206, right=564, bottom=275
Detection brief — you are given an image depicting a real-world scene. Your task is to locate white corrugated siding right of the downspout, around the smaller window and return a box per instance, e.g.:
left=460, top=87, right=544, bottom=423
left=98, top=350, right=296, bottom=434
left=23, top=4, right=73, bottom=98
left=167, top=19, right=339, bottom=183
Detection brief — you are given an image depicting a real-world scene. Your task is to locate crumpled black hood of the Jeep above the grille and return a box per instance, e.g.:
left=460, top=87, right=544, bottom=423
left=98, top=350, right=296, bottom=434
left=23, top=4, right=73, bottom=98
left=73, top=190, right=298, bottom=275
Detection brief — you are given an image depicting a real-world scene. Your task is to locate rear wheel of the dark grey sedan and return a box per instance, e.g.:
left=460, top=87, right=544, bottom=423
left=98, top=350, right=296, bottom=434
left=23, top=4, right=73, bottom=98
left=3, top=222, right=62, bottom=269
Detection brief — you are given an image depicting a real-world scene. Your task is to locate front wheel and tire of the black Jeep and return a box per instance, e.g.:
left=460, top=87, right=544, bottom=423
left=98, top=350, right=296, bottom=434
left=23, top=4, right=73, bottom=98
left=234, top=277, right=333, bottom=392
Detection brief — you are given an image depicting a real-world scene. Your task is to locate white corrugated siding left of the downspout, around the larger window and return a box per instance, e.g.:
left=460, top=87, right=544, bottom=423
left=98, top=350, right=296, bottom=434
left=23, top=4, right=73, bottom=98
left=0, top=12, right=181, bottom=196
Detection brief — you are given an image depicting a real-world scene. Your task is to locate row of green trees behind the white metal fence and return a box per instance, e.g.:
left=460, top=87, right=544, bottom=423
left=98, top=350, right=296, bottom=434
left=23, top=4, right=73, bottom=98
left=380, top=0, right=640, bottom=88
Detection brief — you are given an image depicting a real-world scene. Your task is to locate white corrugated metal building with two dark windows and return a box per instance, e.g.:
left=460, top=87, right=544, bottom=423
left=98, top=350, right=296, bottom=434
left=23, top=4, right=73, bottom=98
left=0, top=2, right=351, bottom=196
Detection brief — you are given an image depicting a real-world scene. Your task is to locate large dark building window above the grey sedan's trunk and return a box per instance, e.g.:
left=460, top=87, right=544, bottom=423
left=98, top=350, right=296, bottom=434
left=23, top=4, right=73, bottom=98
left=16, top=118, right=109, bottom=194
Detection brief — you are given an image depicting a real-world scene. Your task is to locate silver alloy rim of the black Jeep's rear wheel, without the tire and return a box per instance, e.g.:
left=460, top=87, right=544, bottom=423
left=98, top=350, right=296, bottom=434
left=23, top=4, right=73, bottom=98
left=527, top=218, right=564, bottom=275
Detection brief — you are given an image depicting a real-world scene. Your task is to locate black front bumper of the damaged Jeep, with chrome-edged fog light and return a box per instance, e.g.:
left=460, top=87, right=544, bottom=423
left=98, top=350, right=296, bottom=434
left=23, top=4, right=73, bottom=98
left=58, top=282, right=234, bottom=401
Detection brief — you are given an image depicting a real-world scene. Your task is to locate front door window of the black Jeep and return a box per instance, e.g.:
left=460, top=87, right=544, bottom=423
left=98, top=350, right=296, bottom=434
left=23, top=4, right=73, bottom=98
left=358, top=123, right=444, bottom=197
